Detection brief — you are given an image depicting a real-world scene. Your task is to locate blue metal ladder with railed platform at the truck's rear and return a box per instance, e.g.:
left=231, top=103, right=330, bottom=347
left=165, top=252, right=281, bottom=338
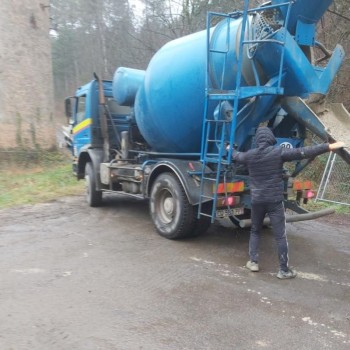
left=198, top=0, right=293, bottom=222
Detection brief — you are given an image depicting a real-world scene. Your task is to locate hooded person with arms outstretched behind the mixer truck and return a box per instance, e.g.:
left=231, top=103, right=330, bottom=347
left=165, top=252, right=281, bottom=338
left=233, top=127, right=344, bottom=279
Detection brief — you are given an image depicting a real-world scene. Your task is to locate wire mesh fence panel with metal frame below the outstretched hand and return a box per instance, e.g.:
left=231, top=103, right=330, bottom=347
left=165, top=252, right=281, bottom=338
left=316, top=152, right=350, bottom=205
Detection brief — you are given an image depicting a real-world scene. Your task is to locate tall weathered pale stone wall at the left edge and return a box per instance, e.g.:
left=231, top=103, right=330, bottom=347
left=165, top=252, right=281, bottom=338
left=0, top=0, right=55, bottom=149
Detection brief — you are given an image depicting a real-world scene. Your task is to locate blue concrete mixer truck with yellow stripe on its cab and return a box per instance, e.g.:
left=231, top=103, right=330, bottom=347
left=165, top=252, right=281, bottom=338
left=66, top=0, right=349, bottom=239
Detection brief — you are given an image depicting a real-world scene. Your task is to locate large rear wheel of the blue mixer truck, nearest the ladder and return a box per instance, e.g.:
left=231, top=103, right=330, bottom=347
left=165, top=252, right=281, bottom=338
left=149, top=173, right=196, bottom=239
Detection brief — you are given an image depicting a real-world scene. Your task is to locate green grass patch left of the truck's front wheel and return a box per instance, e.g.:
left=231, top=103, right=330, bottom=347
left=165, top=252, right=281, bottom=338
left=0, top=162, right=84, bottom=208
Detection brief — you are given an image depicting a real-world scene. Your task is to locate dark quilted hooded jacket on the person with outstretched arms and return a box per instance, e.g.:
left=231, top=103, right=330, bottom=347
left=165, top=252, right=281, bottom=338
left=233, top=127, right=329, bottom=203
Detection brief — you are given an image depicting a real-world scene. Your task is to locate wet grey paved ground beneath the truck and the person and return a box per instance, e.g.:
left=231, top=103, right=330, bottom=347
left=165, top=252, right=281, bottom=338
left=0, top=196, right=350, bottom=350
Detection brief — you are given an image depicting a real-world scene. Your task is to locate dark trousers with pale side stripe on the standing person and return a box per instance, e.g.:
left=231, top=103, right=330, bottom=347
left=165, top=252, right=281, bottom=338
left=249, top=202, right=288, bottom=271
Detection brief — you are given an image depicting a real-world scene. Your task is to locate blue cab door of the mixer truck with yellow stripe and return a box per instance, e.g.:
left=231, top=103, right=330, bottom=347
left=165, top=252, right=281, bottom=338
left=73, top=95, right=92, bottom=156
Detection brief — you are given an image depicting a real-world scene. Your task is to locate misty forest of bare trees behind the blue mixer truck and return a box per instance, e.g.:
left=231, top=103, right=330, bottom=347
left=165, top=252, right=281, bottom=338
left=51, top=0, right=350, bottom=109
